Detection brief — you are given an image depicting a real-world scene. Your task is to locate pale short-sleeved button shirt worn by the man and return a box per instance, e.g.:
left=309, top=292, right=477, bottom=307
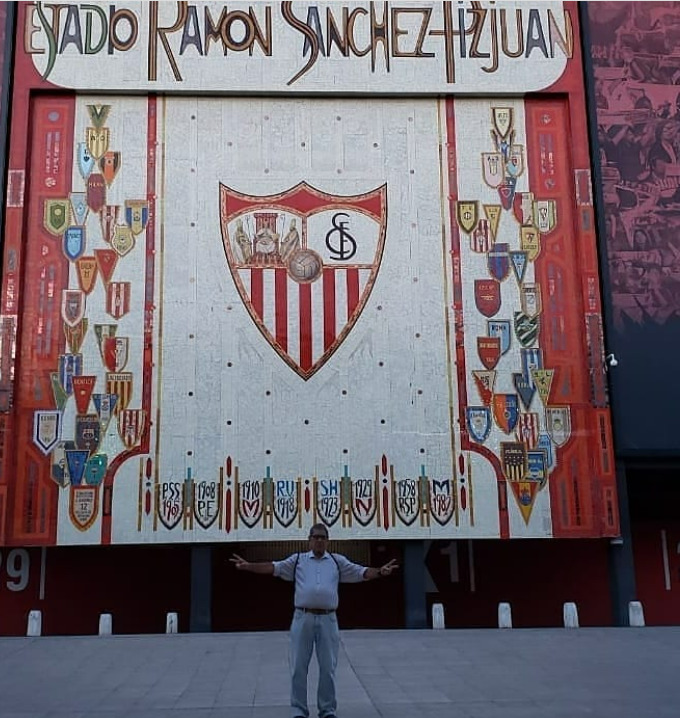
left=273, top=551, right=366, bottom=611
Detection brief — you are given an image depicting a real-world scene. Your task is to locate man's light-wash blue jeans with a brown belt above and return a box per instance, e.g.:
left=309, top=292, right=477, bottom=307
left=290, top=609, right=340, bottom=718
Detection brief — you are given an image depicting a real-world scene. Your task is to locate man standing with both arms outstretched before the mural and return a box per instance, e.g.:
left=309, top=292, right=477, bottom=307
left=231, top=524, right=398, bottom=718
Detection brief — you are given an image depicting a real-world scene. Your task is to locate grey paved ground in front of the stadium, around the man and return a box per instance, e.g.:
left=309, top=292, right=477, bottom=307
left=0, top=628, right=680, bottom=718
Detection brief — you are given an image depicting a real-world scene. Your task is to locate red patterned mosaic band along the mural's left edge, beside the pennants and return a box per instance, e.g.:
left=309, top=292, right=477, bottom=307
left=11, top=95, right=75, bottom=545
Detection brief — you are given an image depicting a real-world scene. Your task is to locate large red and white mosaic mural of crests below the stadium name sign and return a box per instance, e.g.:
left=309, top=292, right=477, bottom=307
left=3, top=4, right=618, bottom=544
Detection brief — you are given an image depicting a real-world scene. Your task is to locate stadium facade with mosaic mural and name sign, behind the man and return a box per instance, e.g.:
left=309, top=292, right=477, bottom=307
left=0, top=2, right=680, bottom=634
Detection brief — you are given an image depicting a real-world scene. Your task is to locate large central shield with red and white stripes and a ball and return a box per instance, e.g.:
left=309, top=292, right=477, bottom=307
left=220, top=182, right=387, bottom=381
